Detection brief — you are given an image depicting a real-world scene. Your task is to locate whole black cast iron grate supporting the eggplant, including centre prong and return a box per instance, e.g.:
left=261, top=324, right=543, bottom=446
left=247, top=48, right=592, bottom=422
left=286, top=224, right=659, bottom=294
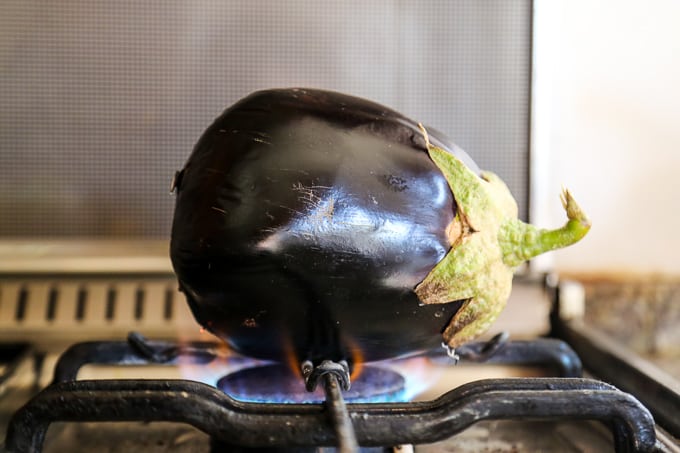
left=6, top=334, right=656, bottom=452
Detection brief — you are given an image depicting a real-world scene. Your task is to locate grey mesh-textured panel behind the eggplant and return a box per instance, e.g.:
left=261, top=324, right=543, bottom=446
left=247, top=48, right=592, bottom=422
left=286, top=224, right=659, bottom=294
left=0, top=0, right=531, bottom=238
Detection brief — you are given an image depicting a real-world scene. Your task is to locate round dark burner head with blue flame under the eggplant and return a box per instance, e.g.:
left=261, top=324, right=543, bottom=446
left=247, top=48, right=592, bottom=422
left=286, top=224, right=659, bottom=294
left=217, top=364, right=406, bottom=403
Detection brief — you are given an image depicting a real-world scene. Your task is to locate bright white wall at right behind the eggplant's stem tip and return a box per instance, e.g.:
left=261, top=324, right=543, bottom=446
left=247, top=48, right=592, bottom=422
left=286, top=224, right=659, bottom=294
left=532, top=0, right=680, bottom=274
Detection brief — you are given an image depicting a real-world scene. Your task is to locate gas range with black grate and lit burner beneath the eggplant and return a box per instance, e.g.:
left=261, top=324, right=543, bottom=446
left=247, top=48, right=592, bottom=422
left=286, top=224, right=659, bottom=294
left=0, top=275, right=680, bottom=452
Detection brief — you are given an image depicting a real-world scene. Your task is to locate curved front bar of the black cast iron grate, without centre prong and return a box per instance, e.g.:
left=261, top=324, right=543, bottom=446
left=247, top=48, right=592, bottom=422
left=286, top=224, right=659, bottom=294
left=6, top=378, right=656, bottom=453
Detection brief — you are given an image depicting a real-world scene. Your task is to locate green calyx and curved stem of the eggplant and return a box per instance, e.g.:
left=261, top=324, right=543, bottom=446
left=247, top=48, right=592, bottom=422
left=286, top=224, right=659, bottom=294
left=415, top=126, right=590, bottom=348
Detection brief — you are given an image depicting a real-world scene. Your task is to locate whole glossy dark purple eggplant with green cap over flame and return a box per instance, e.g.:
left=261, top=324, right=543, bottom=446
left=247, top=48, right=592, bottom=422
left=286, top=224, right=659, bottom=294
left=170, top=89, right=590, bottom=364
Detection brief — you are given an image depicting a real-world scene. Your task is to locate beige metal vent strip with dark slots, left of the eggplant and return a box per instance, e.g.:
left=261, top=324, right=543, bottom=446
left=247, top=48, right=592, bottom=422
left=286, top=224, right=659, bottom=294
left=0, top=275, right=199, bottom=344
